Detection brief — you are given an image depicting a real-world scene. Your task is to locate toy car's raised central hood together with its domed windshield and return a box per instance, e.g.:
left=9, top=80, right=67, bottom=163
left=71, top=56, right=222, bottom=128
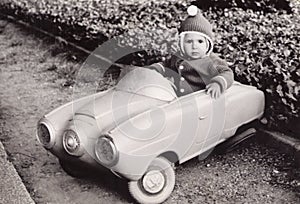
left=74, top=68, right=176, bottom=132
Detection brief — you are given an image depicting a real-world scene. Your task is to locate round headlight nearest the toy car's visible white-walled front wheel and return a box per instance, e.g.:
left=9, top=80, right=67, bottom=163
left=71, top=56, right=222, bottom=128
left=95, top=135, right=119, bottom=166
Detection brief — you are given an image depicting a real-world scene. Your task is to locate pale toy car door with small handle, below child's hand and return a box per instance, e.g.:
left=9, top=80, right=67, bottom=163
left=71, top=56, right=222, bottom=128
left=181, top=91, right=225, bottom=162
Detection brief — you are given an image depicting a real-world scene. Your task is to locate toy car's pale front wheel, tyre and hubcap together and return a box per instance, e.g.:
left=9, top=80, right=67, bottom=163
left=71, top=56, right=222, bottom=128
left=128, top=157, right=175, bottom=203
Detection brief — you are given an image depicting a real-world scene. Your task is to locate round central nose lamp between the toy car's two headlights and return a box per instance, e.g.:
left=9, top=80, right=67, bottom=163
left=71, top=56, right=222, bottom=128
left=63, top=130, right=83, bottom=156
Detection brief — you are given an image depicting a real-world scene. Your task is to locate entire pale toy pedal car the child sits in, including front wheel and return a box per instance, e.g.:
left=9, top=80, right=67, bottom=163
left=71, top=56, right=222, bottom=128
left=37, top=68, right=265, bottom=203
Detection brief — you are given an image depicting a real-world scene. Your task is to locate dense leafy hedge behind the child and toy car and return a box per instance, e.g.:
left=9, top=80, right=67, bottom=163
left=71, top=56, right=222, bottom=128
left=0, top=0, right=300, bottom=135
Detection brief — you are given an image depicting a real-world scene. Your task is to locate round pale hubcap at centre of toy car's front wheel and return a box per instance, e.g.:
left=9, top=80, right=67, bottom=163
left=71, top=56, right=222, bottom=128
left=143, top=170, right=165, bottom=194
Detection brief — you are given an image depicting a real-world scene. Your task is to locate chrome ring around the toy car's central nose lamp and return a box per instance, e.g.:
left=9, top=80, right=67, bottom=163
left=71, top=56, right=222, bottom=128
left=62, top=129, right=83, bottom=157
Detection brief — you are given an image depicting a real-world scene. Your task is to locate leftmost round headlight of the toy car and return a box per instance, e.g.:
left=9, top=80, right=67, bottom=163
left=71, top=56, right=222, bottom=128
left=37, top=121, right=55, bottom=149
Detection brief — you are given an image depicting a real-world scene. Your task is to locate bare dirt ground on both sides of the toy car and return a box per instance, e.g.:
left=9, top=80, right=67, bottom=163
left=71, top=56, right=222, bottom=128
left=0, top=20, right=300, bottom=204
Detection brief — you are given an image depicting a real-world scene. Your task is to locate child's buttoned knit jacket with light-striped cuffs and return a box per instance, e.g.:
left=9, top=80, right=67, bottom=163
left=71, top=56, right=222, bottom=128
left=149, top=53, right=233, bottom=96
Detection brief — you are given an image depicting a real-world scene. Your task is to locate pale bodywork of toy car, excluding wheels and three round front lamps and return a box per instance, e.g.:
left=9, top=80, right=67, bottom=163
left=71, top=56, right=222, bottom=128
left=40, top=69, right=265, bottom=180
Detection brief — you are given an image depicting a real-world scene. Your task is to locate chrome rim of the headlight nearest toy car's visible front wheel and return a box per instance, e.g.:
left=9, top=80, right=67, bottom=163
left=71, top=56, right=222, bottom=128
left=95, top=135, right=119, bottom=167
